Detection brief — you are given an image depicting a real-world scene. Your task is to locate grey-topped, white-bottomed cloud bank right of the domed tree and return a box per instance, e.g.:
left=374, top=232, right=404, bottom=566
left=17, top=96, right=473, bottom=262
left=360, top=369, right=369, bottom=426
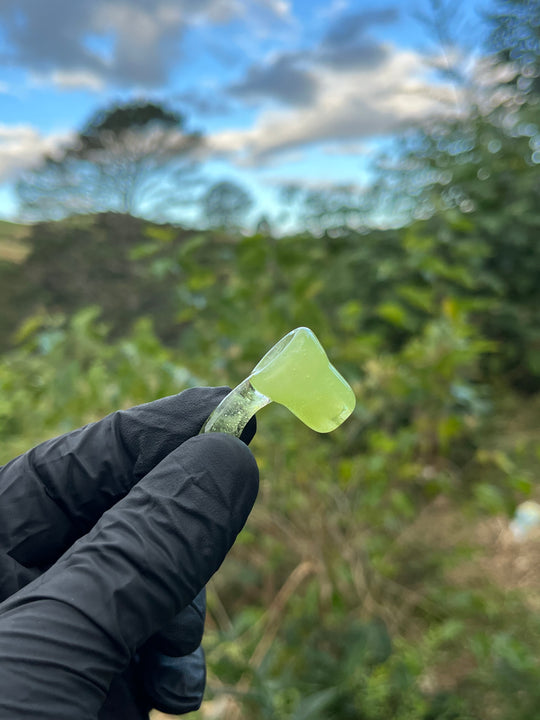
left=209, top=9, right=455, bottom=166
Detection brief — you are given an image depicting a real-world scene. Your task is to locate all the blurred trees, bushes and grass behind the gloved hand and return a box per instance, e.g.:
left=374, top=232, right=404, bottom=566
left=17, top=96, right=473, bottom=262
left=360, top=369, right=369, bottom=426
left=0, top=0, right=540, bottom=720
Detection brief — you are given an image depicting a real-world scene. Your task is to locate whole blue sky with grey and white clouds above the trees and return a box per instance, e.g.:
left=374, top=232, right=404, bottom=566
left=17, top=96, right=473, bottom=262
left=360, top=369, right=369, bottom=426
left=0, top=0, right=490, bottom=225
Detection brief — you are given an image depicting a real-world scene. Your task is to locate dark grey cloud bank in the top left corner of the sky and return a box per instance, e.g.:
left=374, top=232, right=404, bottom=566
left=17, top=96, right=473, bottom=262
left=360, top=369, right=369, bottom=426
left=0, top=0, right=290, bottom=88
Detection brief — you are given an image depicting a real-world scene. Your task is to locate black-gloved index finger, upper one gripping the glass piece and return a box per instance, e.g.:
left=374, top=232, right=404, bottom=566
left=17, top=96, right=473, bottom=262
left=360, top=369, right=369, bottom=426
left=0, top=387, right=229, bottom=576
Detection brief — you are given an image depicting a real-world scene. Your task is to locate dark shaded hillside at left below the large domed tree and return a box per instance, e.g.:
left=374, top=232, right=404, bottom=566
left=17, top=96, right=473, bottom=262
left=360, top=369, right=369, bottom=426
left=0, top=214, right=192, bottom=349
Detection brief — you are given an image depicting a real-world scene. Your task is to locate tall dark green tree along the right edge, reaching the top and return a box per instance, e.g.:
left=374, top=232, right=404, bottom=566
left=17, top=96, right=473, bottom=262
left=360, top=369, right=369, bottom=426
left=356, top=0, right=540, bottom=392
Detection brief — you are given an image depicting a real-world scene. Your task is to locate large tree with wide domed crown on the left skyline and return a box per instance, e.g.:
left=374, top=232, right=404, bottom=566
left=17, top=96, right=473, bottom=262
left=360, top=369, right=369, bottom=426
left=17, top=102, right=203, bottom=219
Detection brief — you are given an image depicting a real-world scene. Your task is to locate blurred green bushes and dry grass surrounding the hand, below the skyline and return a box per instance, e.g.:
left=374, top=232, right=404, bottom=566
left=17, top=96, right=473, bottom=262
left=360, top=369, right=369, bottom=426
left=4, top=224, right=538, bottom=720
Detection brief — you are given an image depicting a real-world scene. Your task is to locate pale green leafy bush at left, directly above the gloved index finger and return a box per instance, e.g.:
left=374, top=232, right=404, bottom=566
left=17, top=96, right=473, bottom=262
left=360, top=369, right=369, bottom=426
left=0, top=307, right=197, bottom=462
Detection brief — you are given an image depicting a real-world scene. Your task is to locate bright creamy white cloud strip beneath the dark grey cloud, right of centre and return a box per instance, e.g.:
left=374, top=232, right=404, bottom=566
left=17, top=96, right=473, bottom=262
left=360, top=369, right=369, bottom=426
left=209, top=48, right=454, bottom=165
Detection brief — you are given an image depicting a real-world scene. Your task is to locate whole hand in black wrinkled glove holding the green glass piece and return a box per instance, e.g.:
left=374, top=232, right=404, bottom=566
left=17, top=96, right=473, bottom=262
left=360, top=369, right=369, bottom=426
left=0, top=388, right=258, bottom=720
